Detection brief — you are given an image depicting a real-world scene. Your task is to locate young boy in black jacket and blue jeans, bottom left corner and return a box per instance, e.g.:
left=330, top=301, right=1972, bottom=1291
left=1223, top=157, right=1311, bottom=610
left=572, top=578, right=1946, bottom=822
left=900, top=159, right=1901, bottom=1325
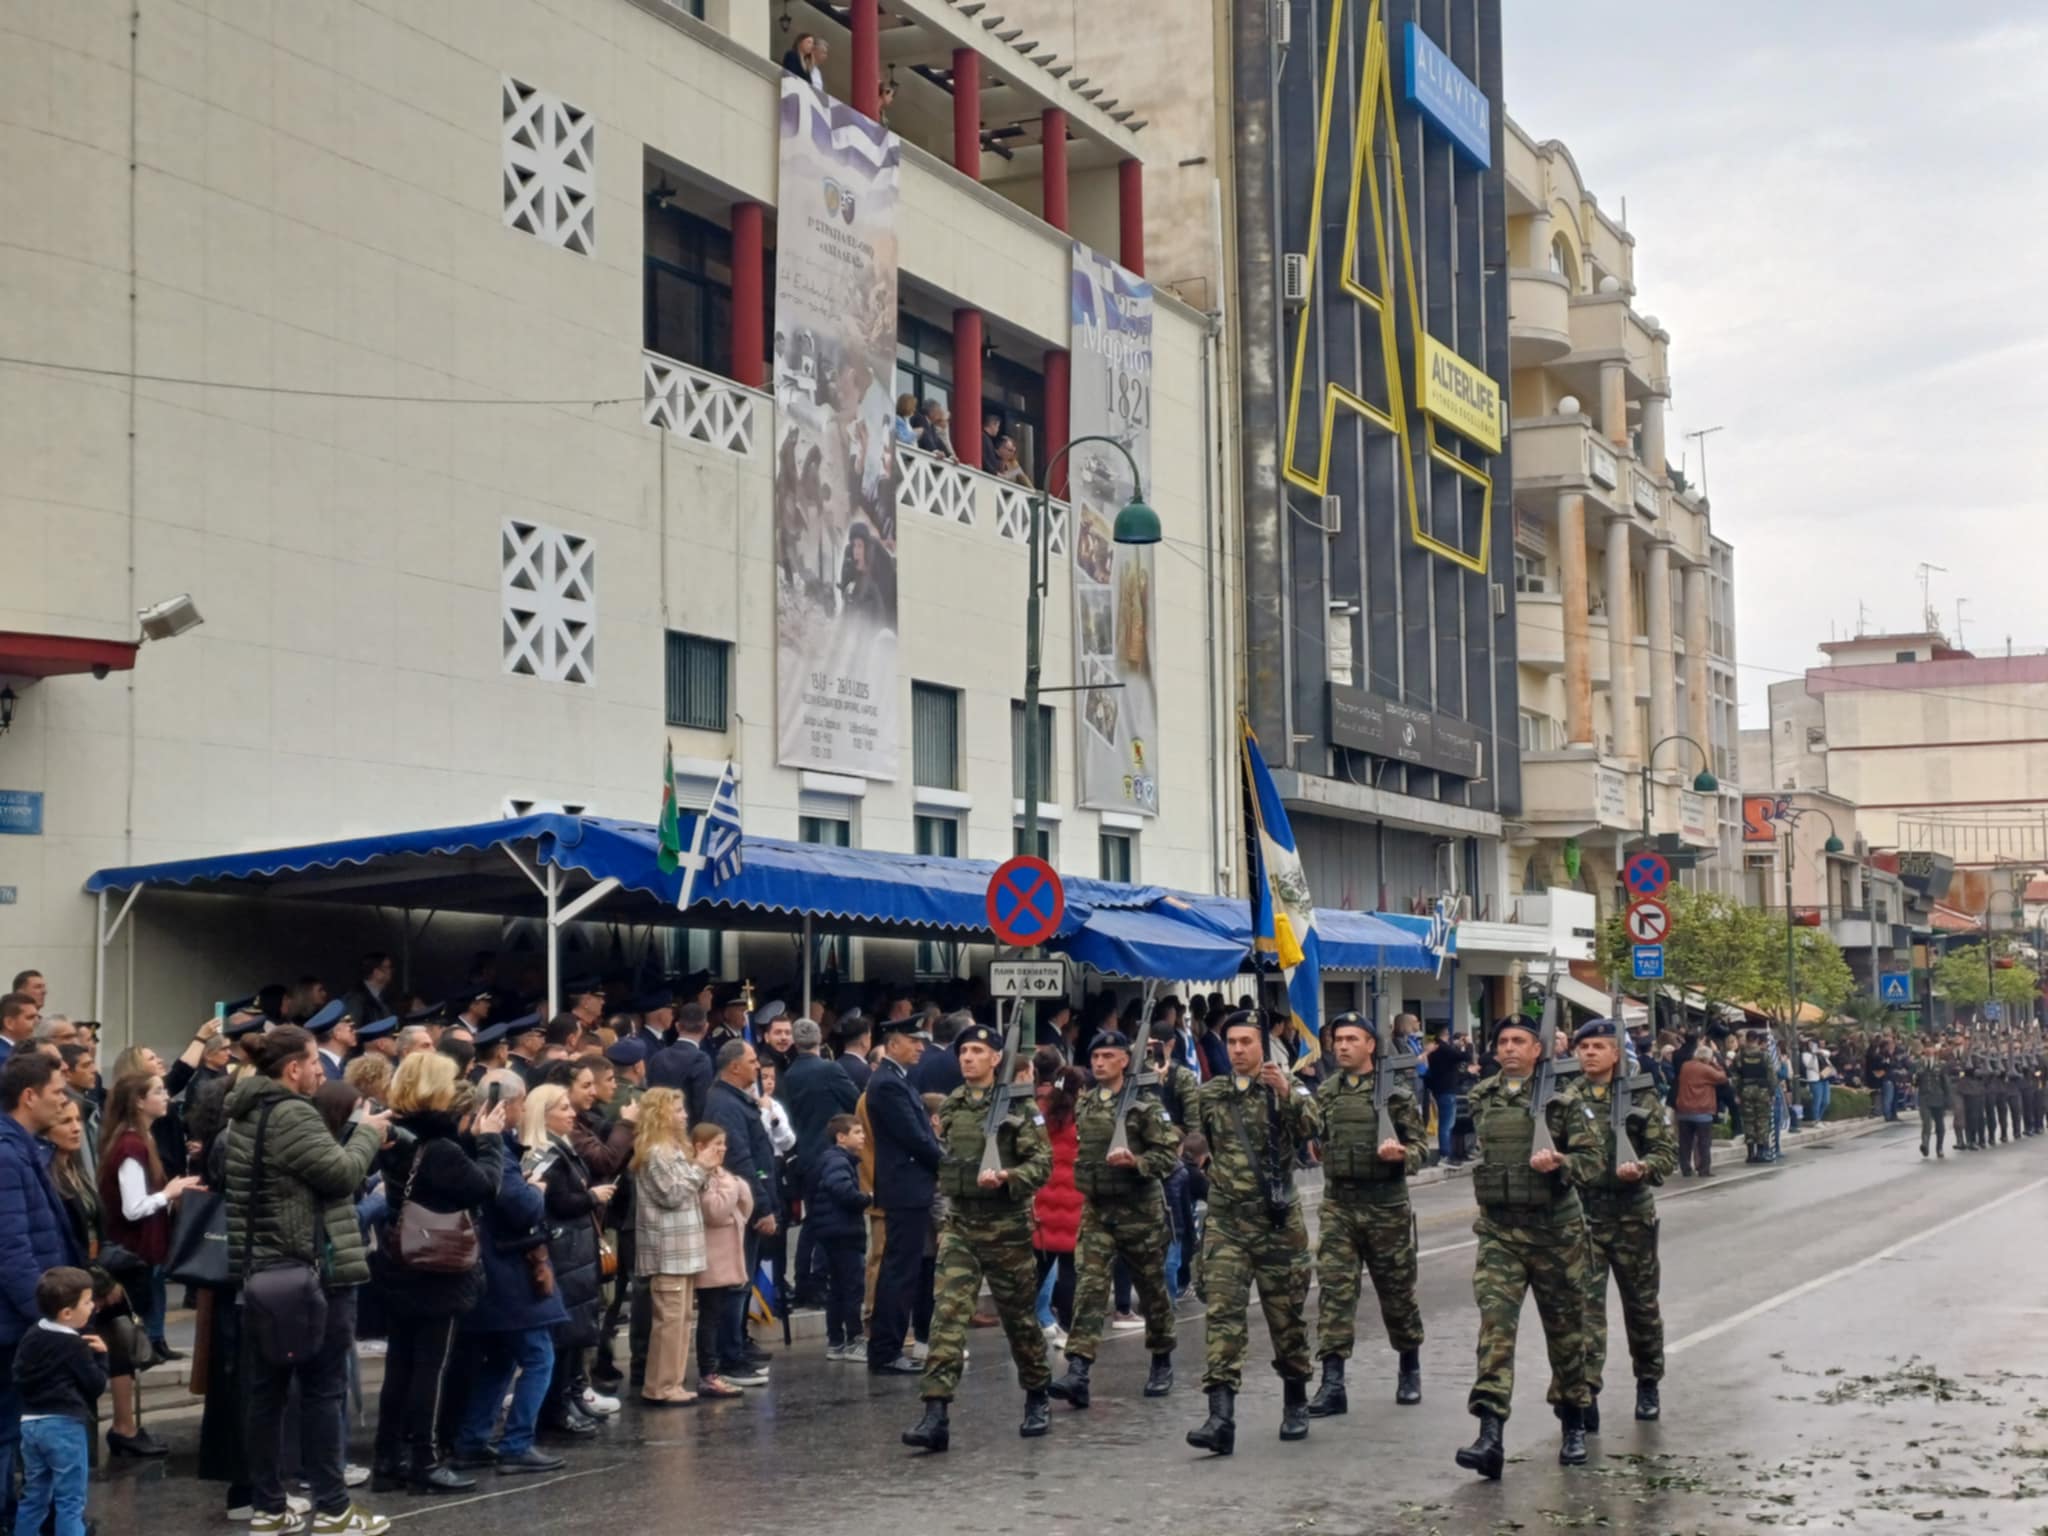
left=14, top=1266, right=106, bottom=1536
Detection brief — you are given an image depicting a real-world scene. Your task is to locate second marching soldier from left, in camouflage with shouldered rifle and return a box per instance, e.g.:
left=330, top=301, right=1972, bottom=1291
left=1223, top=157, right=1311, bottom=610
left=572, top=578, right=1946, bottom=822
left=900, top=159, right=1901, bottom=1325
left=1053, top=1030, right=1180, bottom=1409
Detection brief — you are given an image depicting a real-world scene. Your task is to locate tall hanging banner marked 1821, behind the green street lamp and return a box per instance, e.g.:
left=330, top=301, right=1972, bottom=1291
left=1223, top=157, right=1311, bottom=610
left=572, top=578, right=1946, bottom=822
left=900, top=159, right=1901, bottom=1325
left=1067, top=242, right=1159, bottom=815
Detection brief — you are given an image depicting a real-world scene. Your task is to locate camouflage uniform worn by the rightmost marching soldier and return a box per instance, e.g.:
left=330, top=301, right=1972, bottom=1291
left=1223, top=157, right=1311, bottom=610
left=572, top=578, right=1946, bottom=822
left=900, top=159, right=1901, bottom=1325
left=1552, top=1079, right=1677, bottom=1397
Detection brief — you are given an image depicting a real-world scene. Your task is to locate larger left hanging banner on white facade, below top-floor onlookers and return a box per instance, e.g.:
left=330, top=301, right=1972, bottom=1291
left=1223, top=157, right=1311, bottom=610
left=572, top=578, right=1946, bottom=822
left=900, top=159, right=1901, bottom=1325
left=774, top=76, right=901, bottom=778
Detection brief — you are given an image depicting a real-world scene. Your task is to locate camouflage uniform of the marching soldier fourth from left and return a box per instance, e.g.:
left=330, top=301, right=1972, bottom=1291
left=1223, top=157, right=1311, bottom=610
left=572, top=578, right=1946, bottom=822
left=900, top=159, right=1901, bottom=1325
left=1315, top=1071, right=1425, bottom=1360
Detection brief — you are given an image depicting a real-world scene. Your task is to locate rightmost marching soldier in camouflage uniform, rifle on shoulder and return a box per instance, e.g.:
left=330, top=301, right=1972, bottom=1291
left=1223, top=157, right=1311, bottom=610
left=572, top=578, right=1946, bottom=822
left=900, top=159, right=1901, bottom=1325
left=1571, top=1018, right=1677, bottom=1434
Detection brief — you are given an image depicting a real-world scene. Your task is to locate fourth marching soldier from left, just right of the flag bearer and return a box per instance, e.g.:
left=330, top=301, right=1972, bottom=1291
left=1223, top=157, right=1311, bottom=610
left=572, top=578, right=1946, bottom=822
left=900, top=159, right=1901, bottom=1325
left=1309, top=1014, right=1427, bottom=1419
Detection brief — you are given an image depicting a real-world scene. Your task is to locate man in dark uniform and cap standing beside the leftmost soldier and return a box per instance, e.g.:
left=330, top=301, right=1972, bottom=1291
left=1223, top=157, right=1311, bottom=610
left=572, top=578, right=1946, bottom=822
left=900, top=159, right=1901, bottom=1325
left=866, top=1018, right=946, bottom=1376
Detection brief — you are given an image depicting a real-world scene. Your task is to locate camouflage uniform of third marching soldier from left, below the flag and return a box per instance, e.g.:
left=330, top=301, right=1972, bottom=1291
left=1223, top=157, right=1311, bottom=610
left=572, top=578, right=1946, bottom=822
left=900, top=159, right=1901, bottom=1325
left=1190, top=1077, right=1323, bottom=1393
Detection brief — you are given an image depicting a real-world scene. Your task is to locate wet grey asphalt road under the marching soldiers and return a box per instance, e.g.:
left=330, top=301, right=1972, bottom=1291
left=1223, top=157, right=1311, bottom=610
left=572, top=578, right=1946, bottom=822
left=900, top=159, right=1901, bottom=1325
left=92, top=1126, right=2048, bottom=1536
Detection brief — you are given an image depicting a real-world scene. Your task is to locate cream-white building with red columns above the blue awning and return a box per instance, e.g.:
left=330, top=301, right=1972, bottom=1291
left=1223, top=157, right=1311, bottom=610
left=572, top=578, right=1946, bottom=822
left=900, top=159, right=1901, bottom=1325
left=0, top=0, right=1237, bottom=1026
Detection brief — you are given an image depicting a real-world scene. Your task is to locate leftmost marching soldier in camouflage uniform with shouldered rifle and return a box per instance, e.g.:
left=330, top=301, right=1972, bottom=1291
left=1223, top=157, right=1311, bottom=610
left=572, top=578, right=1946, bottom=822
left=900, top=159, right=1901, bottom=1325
left=903, top=1024, right=1053, bottom=1450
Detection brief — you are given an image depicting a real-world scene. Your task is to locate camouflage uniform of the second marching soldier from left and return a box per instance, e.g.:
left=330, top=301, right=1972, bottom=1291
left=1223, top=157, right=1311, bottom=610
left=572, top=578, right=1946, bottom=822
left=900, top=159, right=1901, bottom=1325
left=1067, top=1087, right=1180, bottom=1360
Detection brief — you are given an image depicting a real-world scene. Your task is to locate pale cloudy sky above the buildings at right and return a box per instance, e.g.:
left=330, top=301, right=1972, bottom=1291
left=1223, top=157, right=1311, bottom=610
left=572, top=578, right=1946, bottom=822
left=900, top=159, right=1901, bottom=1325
left=1503, top=0, right=2048, bottom=725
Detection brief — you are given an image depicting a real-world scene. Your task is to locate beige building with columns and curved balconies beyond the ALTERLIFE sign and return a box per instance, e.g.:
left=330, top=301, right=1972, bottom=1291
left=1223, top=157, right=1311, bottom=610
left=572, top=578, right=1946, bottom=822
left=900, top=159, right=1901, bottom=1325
left=1505, top=123, right=1743, bottom=903
